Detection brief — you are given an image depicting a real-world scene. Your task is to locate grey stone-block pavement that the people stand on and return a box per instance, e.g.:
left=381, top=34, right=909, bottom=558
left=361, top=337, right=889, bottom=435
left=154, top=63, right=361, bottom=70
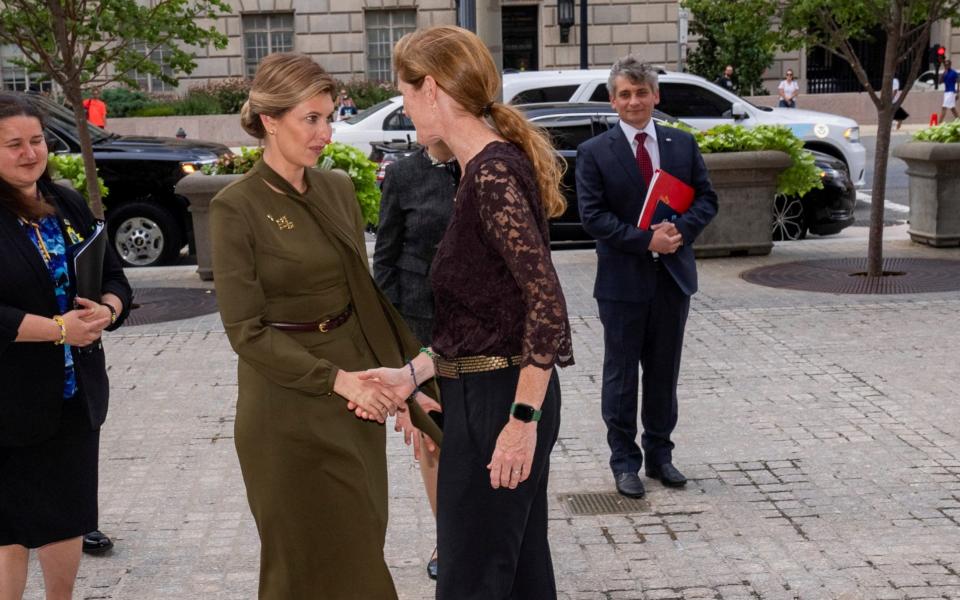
left=27, top=226, right=960, bottom=600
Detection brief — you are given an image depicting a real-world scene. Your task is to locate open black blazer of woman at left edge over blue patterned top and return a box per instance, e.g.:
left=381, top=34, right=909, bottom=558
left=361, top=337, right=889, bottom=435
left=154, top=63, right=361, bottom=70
left=0, top=181, right=133, bottom=446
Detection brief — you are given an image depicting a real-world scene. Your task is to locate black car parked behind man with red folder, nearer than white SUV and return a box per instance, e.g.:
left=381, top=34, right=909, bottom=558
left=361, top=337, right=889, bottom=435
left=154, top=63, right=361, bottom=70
left=370, top=102, right=856, bottom=246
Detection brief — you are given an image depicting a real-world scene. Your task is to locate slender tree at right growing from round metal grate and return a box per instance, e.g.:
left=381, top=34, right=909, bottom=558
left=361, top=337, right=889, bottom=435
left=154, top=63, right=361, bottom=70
left=772, top=0, right=960, bottom=277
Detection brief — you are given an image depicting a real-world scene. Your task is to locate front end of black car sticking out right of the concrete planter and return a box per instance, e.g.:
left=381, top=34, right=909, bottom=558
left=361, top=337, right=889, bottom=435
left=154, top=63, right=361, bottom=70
left=773, top=151, right=857, bottom=241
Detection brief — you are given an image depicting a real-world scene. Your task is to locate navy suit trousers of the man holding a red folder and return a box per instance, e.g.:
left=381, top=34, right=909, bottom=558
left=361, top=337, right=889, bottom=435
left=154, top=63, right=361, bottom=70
left=597, top=265, right=690, bottom=474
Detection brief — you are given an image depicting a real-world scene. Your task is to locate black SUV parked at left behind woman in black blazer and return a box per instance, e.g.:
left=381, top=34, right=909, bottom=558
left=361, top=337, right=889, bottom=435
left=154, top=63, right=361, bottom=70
left=29, top=95, right=230, bottom=267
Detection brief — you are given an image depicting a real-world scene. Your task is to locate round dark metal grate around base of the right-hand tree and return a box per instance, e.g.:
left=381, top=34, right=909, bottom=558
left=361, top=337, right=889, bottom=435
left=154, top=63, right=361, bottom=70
left=740, top=258, right=960, bottom=294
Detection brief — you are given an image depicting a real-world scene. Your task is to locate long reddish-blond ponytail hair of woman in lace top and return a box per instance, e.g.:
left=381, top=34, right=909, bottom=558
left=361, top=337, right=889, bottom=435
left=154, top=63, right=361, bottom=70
left=393, top=25, right=567, bottom=217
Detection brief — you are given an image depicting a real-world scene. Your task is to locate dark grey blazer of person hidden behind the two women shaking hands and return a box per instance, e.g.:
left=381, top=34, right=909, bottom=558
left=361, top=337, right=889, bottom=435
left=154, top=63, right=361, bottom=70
left=373, top=150, right=458, bottom=342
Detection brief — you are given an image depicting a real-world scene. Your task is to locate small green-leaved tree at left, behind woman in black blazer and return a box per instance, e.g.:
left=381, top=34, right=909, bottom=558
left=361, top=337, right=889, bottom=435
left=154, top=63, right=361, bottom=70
left=0, top=0, right=230, bottom=218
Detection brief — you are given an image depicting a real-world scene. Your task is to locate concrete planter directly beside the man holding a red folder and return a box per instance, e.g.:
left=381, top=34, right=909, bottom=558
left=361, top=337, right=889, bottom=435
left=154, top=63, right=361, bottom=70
left=693, top=150, right=791, bottom=257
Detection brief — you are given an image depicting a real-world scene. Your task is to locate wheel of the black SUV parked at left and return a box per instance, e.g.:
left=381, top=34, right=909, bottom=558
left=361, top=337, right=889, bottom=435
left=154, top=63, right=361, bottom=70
left=109, top=202, right=184, bottom=267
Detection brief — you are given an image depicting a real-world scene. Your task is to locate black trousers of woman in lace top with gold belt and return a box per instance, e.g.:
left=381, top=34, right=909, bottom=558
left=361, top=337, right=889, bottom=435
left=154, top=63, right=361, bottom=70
left=437, top=367, right=560, bottom=600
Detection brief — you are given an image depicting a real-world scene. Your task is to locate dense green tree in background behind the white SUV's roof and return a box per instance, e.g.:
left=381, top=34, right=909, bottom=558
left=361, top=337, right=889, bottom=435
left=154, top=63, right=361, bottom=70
left=682, top=0, right=777, bottom=96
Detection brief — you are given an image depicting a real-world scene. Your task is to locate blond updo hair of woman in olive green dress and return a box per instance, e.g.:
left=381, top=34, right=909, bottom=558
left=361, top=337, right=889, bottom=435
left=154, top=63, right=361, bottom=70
left=240, top=52, right=337, bottom=140
